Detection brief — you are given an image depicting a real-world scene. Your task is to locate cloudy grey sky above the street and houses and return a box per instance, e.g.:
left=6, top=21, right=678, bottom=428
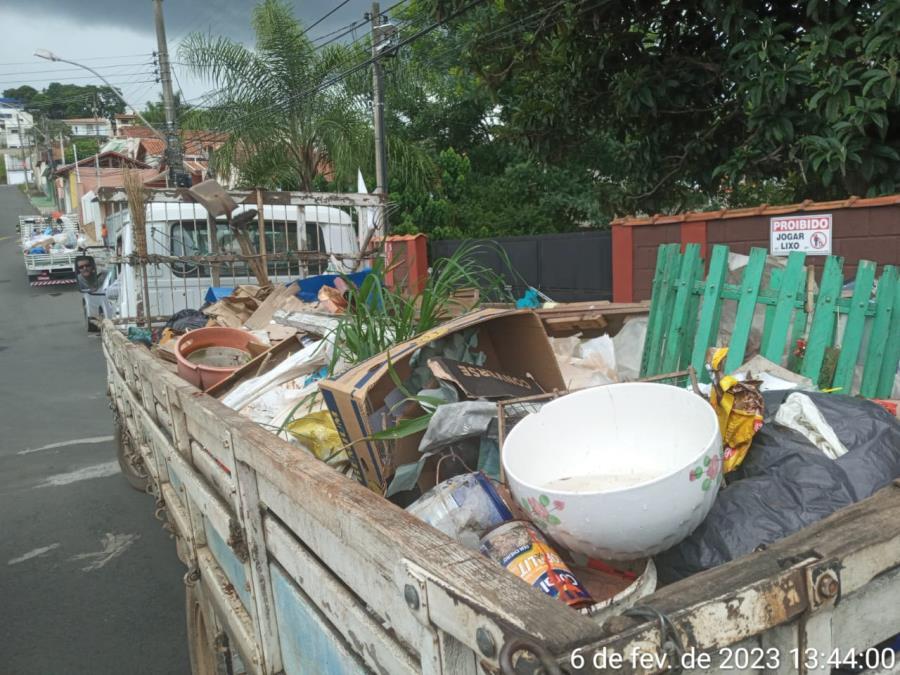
left=0, top=0, right=372, bottom=112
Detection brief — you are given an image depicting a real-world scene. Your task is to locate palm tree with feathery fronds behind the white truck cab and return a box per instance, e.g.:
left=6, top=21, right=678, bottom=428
left=179, top=0, right=374, bottom=190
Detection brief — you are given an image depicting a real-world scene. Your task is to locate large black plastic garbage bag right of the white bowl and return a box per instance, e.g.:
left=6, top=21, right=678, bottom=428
left=654, top=392, right=900, bottom=584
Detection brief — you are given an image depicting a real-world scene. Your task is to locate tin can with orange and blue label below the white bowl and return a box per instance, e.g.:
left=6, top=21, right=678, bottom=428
left=481, top=520, right=594, bottom=607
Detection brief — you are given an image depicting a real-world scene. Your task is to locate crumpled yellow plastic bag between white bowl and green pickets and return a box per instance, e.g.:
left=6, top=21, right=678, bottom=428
left=709, top=347, right=764, bottom=473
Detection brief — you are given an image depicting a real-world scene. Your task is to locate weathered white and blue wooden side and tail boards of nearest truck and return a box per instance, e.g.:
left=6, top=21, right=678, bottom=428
left=103, top=321, right=900, bottom=675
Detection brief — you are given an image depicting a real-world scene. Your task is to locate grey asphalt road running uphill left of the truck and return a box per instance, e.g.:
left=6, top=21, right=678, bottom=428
left=0, top=186, right=190, bottom=675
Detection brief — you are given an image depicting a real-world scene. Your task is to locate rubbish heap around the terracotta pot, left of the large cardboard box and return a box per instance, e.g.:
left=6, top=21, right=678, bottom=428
left=135, top=272, right=378, bottom=473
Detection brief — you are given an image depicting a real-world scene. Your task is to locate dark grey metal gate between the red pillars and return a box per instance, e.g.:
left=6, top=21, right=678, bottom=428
left=431, top=230, right=612, bottom=302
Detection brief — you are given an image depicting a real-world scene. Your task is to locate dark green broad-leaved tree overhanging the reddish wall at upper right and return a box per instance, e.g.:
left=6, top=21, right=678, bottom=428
left=422, top=0, right=900, bottom=211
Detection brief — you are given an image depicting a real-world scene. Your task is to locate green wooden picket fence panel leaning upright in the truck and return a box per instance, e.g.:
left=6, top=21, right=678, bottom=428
left=641, top=244, right=900, bottom=398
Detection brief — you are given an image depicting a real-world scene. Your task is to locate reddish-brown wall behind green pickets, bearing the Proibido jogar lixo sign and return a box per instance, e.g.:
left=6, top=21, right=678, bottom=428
left=613, top=205, right=900, bottom=301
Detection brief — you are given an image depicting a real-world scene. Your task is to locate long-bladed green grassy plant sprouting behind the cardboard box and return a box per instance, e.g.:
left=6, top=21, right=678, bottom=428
left=329, top=243, right=512, bottom=374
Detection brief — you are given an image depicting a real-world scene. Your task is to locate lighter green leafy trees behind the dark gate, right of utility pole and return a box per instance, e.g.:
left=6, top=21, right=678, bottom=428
left=366, top=0, right=608, bottom=238
